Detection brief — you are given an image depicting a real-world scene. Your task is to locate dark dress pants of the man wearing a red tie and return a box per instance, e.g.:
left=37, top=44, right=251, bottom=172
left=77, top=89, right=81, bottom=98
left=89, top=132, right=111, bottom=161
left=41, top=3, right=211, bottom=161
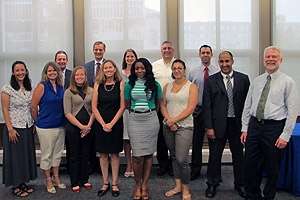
left=191, top=108, right=205, bottom=172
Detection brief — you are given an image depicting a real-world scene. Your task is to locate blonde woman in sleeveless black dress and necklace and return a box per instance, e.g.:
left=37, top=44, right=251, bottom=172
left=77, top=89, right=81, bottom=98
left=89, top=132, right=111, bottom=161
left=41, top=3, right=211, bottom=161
left=92, top=60, right=125, bottom=197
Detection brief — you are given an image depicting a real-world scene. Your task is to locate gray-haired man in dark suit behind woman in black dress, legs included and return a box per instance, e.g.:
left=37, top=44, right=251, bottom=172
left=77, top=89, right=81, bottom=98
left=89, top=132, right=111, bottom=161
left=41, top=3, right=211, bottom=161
left=84, top=41, right=106, bottom=174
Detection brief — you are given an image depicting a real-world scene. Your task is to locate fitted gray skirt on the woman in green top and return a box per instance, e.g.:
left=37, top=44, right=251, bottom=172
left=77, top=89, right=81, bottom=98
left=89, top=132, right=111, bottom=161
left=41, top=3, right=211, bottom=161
left=128, top=111, right=159, bottom=156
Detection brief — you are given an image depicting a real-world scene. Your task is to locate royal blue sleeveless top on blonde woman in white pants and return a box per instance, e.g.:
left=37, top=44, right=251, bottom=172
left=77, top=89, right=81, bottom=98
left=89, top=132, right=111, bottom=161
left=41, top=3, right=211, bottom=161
left=36, top=82, right=66, bottom=128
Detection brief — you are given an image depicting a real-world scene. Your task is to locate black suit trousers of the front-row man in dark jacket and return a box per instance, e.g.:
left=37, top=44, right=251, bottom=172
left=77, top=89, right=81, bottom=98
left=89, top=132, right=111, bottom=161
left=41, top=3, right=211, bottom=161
left=207, top=117, right=244, bottom=187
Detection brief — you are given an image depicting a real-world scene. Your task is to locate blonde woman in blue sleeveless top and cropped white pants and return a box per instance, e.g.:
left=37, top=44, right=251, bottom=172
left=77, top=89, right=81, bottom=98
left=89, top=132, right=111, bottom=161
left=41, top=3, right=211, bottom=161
left=31, top=62, right=66, bottom=194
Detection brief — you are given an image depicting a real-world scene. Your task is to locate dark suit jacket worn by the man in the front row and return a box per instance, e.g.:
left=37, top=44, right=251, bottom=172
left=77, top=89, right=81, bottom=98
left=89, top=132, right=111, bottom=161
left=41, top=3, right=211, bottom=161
left=202, top=71, right=250, bottom=139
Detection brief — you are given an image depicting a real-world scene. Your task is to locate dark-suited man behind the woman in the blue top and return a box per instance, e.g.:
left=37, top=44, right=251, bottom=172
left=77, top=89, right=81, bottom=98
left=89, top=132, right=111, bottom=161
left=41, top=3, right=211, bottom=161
left=54, top=50, right=72, bottom=90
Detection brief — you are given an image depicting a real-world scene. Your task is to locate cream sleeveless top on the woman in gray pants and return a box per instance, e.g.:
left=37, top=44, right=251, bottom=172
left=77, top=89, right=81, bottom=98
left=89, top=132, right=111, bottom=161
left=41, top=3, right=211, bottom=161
left=166, top=81, right=193, bottom=127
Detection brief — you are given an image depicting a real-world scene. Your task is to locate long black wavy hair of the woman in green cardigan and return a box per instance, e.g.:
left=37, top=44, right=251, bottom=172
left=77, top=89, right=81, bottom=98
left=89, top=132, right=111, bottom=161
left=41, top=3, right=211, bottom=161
left=129, top=58, right=157, bottom=94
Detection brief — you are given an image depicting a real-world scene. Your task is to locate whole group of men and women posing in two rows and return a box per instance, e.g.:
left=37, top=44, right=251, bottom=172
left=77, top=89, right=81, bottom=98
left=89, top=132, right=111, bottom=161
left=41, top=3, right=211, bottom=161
left=1, top=41, right=298, bottom=200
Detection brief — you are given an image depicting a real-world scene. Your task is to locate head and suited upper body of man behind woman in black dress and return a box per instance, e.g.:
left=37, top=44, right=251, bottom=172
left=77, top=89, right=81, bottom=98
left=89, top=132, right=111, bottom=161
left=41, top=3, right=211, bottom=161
left=84, top=41, right=106, bottom=87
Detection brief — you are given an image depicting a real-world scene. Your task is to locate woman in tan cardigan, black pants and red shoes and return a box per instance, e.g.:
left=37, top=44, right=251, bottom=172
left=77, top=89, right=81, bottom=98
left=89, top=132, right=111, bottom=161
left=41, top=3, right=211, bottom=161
left=64, top=66, right=94, bottom=192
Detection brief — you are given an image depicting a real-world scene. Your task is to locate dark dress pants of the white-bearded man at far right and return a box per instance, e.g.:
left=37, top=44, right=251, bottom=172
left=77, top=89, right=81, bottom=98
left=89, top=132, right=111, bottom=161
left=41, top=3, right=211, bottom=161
left=245, top=117, right=285, bottom=199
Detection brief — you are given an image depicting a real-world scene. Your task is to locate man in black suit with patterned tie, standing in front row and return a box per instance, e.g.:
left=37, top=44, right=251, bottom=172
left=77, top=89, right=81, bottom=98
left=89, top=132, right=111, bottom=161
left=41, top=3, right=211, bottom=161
left=202, top=51, right=250, bottom=198
